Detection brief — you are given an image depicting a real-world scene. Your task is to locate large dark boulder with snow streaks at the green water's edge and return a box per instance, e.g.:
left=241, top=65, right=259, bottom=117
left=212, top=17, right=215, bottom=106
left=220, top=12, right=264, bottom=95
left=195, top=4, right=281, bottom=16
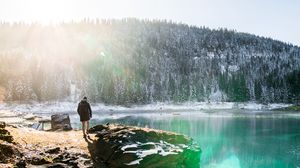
left=89, top=125, right=201, bottom=168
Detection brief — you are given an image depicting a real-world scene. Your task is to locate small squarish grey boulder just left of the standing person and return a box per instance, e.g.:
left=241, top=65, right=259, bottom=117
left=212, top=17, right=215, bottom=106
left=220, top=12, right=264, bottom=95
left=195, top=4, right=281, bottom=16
left=51, top=114, right=72, bottom=131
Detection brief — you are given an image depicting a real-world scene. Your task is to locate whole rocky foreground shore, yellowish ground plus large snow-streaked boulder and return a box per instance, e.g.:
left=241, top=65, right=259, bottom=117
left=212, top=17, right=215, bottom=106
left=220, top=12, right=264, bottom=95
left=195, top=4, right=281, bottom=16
left=0, top=122, right=201, bottom=168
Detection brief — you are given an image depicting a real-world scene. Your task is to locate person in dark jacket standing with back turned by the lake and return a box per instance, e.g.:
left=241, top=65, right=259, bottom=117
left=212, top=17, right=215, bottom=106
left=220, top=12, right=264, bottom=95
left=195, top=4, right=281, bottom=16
left=77, top=97, right=92, bottom=137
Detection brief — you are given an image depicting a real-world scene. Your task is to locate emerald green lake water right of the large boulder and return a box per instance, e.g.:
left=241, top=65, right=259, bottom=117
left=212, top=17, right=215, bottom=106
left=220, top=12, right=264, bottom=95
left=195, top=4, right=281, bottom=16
left=74, top=111, right=300, bottom=168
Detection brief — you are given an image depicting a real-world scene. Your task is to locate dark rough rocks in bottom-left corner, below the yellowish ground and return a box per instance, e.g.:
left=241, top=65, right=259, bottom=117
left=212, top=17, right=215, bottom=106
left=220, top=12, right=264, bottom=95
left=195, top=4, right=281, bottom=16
left=0, top=122, right=93, bottom=168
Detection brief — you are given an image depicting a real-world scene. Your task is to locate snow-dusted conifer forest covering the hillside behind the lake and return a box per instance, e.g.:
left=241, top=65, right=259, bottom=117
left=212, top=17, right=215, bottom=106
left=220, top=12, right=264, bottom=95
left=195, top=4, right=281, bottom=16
left=0, top=19, right=300, bottom=104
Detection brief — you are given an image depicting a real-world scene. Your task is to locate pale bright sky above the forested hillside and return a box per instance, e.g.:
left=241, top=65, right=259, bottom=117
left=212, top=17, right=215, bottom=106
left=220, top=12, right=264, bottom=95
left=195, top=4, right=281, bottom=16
left=0, top=0, right=300, bottom=46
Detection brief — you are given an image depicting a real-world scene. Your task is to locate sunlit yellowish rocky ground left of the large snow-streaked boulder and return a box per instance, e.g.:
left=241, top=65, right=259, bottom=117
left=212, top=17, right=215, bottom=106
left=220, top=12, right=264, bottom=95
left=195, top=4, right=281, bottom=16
left=0, top=122, right=93, bottom=168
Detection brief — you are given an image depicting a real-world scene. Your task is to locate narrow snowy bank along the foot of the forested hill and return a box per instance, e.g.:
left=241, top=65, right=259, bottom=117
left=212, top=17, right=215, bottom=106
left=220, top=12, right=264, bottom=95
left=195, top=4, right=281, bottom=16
left=0, top=102, right=291, bottom=113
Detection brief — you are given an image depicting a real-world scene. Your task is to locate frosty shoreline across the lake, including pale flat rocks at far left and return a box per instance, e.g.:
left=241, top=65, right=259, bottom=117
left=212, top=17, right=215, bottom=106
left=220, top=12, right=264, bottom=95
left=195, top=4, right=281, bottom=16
left=0, top=102, right=300, bottom=130
